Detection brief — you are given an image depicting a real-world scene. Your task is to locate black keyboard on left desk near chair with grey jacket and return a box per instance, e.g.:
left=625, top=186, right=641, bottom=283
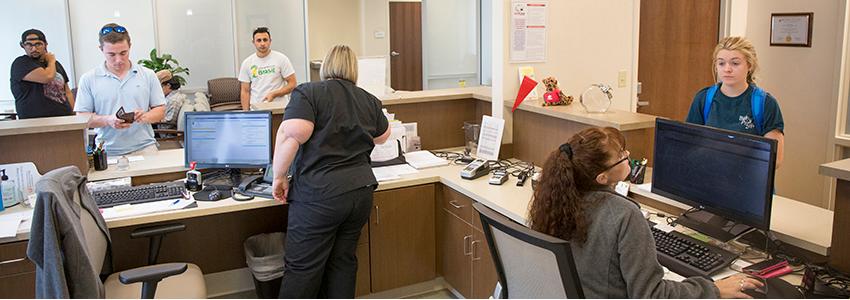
left=91, top=182, right=186, bottom=208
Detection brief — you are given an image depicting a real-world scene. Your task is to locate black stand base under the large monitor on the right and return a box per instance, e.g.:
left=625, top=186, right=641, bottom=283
left=676, top=210, right=752, bottom=243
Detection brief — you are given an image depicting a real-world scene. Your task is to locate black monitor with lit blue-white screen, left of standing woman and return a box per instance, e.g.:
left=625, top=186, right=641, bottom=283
left=183, top=111, right=272, bottom=168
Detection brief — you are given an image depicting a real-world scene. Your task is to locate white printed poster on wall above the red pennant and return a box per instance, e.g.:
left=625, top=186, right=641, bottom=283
left=510, top=0, right=549, bottom=62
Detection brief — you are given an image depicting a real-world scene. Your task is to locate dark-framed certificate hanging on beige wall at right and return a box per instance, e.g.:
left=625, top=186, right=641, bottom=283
left=770, top=13, right=814, bottom=47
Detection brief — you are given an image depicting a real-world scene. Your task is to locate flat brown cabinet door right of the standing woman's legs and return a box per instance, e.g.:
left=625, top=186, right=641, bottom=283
left=369, top=184, right=437, bottom=293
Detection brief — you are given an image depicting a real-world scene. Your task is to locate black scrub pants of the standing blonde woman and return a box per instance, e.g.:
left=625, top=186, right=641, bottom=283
left=279, top=186, right=375, bottom=299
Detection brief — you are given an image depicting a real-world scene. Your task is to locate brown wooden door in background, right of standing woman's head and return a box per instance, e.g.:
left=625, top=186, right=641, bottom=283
left=389, top=2, right=422, bottom=91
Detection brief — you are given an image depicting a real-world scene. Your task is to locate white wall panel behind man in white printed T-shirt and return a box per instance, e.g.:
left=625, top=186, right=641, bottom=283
left=233, top=0, right=310, bottom=83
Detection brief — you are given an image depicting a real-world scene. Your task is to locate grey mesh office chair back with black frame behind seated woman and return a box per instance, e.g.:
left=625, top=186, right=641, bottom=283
left=472, top=203, right=584, bottom=299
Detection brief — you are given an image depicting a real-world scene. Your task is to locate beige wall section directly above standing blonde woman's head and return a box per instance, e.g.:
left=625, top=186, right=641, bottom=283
left=307, top=0, right=363, bottom=60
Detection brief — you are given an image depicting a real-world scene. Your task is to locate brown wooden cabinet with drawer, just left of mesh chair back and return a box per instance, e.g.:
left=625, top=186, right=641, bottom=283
left=437, top=186, right=498, bottom=299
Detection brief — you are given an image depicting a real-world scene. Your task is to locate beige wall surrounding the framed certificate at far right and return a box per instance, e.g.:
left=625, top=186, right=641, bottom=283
left=746, top=0, right=844, bottom=208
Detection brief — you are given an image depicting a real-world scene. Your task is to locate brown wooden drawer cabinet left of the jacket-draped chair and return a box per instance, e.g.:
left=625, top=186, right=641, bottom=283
left=0, top=241, right=35, bottom=298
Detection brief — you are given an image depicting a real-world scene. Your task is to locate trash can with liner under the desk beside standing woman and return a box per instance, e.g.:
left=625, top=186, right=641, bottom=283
left=245, top=232, right=286, bottom=299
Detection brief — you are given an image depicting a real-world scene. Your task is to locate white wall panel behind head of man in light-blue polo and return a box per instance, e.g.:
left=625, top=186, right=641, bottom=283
left=68, top=0, right=156, bottom=82
